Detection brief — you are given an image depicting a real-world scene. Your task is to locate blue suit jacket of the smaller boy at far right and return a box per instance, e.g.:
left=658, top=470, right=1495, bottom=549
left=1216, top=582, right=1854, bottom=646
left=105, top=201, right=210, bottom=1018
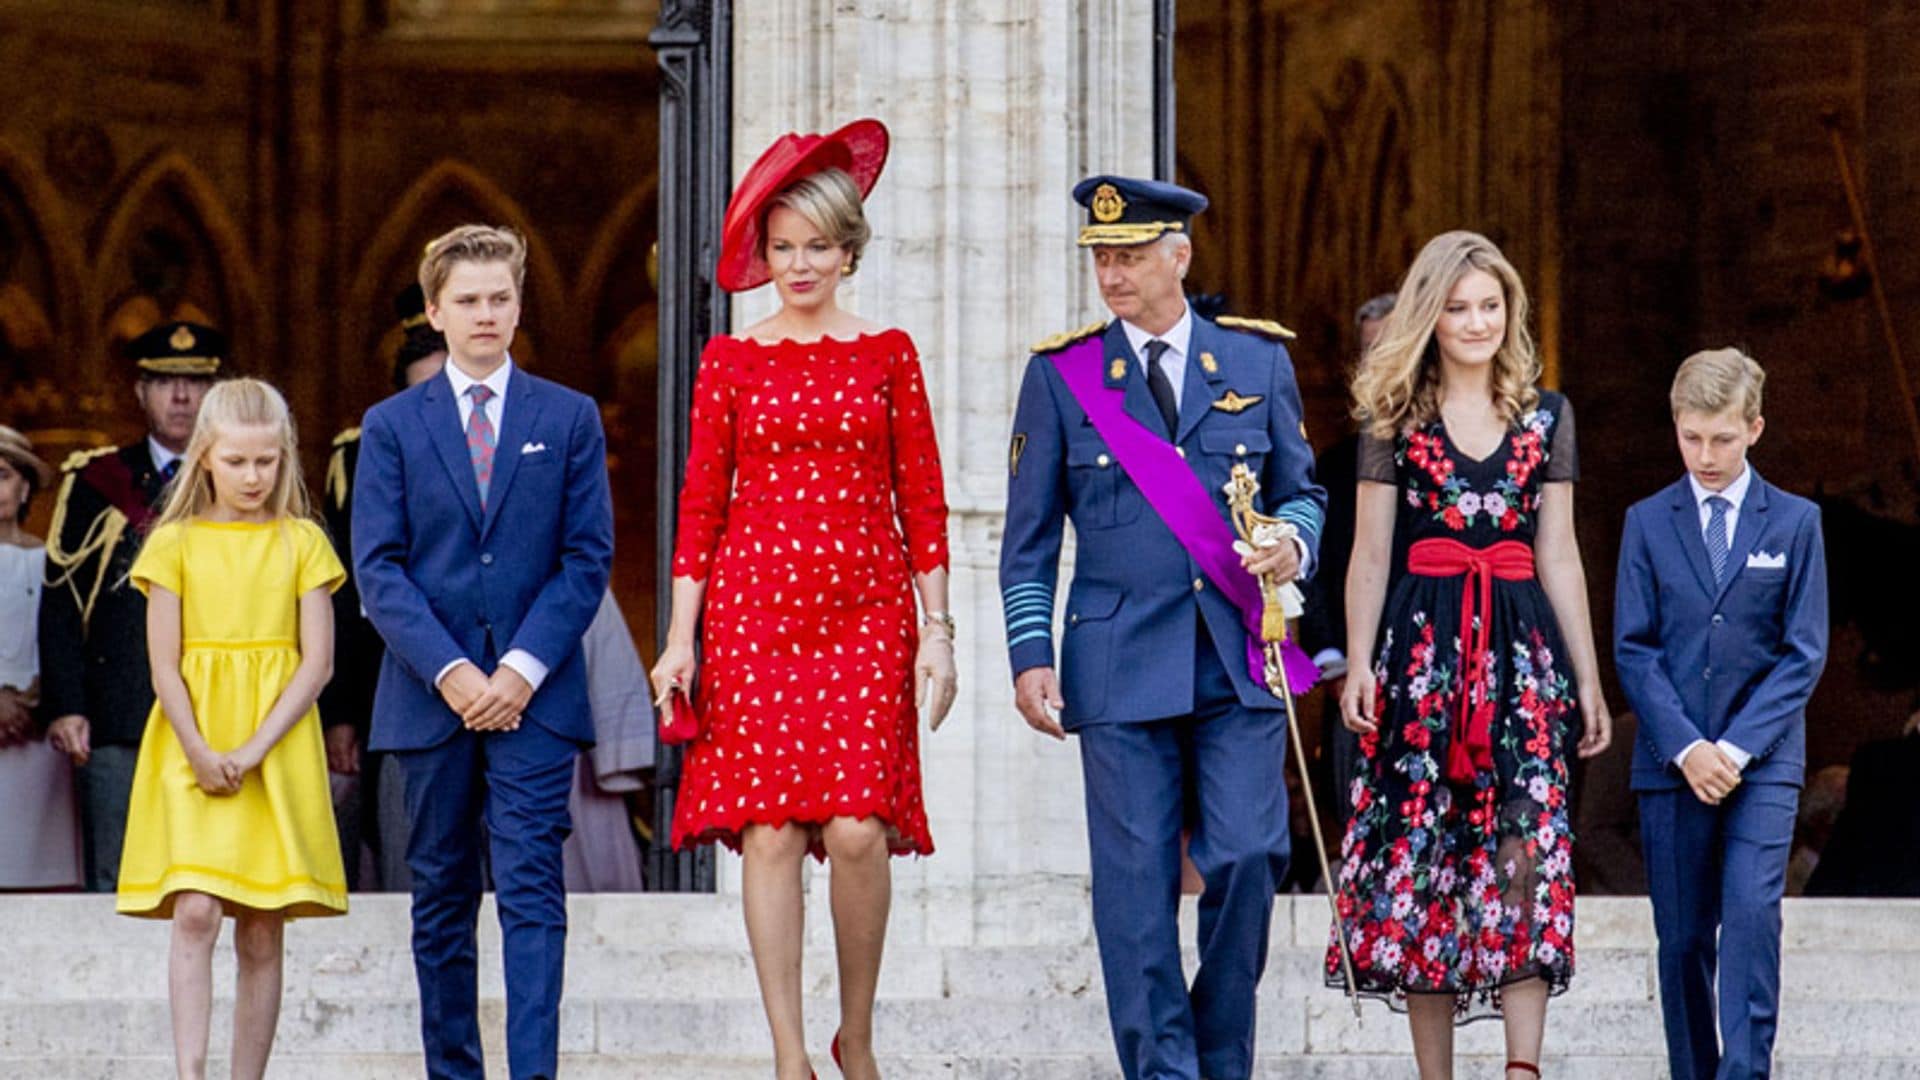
left=1613, top=463, right=1828, bottom=792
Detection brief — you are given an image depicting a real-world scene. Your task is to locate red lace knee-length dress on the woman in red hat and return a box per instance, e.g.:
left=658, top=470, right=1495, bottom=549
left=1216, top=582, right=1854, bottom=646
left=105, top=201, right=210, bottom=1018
left=674, top=331, right=947, bottom=857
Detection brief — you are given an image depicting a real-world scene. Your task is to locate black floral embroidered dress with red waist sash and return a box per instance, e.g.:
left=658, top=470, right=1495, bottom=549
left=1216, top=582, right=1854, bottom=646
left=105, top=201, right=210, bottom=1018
left=1327, top=392, right=1578, bottom=1022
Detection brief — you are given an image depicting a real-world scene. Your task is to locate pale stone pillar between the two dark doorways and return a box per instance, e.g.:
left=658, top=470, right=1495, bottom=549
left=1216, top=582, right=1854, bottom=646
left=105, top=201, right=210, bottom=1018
left=720, top=0, right=1154, bottom=942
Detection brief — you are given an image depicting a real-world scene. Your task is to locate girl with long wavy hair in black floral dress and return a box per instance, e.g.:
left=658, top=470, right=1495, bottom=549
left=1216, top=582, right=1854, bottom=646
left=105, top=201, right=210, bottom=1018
left=1327, top=233, right=1611, bottom=1080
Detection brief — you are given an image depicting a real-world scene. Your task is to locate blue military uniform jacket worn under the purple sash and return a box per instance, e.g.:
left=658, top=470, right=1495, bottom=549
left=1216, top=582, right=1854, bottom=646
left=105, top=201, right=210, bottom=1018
left=1000, top=313, right=1327, bottom=728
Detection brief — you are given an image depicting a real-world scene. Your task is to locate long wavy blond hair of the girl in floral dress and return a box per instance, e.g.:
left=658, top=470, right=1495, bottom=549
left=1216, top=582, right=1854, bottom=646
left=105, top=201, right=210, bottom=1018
left=1354, top=231, right=1540, bottom=438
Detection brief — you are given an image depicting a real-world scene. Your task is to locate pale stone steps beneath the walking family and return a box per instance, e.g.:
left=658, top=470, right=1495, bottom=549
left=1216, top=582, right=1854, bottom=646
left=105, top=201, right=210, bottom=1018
left=0, top=874, right=1920, bottom=1080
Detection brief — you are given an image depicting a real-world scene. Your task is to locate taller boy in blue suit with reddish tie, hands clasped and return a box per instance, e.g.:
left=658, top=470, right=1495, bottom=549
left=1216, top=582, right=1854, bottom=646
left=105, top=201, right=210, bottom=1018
left=353, top=225, right=612, bottom=1080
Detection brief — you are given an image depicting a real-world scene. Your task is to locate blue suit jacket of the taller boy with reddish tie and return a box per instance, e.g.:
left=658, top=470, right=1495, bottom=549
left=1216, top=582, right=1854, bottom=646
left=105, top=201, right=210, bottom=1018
left=353, top=365, right=612, bottom=749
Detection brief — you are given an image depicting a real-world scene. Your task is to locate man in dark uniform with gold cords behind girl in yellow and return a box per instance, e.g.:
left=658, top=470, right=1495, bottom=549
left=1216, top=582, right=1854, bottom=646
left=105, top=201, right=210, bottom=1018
left=40, top=323, right=227, bottom=892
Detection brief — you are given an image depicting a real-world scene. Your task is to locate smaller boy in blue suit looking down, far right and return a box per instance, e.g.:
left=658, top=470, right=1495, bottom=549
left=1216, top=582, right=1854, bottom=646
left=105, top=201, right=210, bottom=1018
left=1613, top=348, right=1828, bottom=1080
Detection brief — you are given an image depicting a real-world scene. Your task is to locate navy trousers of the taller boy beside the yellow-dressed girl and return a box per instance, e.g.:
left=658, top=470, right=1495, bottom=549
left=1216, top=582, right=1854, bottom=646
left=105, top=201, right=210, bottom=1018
left=396, top=721, right=580, bottom=1080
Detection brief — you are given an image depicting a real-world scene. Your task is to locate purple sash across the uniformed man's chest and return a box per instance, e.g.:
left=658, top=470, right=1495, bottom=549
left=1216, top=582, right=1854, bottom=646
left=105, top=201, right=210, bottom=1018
left=1054, top=336, right=1319, bottom=694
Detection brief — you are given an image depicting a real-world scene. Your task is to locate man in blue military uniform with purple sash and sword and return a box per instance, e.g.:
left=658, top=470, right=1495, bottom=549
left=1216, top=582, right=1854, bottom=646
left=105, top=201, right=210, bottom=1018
left=1000, top=177, right=1325, bottom=1080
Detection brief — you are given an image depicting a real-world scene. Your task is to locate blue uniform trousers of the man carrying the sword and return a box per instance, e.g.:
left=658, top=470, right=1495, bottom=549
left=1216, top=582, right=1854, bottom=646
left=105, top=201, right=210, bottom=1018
left=1075, top=630, right=1288, bottom=1080
